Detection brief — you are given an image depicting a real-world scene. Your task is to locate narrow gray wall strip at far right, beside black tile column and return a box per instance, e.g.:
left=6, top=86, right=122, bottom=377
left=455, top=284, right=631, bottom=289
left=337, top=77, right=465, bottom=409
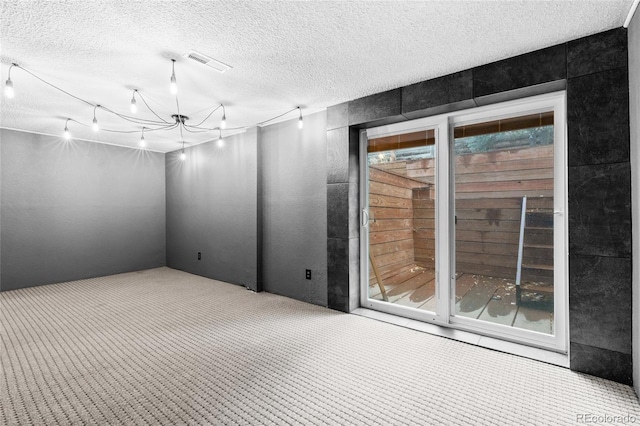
left=628, top=11, right=640, bottom=395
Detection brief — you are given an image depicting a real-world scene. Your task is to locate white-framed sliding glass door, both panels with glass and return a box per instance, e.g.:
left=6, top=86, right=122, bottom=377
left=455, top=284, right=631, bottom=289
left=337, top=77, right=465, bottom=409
left=361, top=91, right=567, bottom=351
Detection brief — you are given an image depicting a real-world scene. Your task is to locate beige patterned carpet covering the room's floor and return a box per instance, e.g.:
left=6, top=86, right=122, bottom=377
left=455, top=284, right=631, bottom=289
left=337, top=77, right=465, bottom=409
left=0, top=268, right=640, bottom=426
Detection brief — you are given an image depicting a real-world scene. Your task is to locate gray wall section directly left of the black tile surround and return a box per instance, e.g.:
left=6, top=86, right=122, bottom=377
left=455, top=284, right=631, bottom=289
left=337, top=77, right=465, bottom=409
left=260, top=111, right=327, bottom=306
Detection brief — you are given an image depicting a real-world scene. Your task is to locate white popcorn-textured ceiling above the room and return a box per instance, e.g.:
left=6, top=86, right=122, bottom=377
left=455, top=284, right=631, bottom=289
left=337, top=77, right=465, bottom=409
left=0, top=0, right=633, bottom=152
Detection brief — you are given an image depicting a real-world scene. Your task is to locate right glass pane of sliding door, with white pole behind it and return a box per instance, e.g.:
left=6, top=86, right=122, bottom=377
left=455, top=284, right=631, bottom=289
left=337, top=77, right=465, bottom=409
left=453, top=112, right=554, bottom=334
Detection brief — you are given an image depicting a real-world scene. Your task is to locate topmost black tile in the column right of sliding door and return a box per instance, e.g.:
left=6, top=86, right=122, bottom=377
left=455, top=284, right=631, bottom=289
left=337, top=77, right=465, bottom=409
left=567, top=28, right=628, bottom=78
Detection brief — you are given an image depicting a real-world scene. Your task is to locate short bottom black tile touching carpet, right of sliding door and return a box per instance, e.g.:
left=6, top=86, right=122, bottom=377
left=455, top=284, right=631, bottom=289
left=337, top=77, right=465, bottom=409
left=570, top=343, right=633, bottom=385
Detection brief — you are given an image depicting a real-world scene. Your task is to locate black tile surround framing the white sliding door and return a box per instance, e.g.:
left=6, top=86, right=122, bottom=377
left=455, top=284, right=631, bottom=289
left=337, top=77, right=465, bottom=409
left=327, top=28, right=632, bottom=383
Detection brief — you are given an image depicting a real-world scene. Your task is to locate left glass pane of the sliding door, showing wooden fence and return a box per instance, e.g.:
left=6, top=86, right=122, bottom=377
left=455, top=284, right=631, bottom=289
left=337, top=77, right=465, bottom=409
left=367, top=130, right=436, bottom=311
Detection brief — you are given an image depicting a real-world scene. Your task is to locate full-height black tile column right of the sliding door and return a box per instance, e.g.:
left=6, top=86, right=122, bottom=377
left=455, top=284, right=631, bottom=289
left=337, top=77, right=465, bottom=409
left=567, top=28, right=632, bottom=384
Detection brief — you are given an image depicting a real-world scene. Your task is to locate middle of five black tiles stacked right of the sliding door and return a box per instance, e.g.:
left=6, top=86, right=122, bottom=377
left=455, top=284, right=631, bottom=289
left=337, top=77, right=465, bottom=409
left=568, top=163, right=631, bottom=257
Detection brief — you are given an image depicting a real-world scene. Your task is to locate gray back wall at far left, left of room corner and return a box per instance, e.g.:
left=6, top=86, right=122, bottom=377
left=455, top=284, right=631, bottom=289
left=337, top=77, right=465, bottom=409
left=0, top=129, right=165, bottom=290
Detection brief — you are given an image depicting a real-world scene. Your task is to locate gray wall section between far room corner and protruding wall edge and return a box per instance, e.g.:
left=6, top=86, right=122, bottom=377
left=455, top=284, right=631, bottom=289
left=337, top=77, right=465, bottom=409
left=166, top=128, right=258, bottom=289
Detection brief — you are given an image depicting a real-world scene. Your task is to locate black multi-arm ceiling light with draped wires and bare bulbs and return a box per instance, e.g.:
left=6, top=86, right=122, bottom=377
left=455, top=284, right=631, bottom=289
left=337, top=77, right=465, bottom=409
left=4, top=59, right=302, bottom=153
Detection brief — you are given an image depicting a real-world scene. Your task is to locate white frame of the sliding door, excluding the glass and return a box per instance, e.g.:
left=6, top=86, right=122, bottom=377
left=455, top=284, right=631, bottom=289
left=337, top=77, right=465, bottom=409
left=360, top=91, right=569, bottom=353
